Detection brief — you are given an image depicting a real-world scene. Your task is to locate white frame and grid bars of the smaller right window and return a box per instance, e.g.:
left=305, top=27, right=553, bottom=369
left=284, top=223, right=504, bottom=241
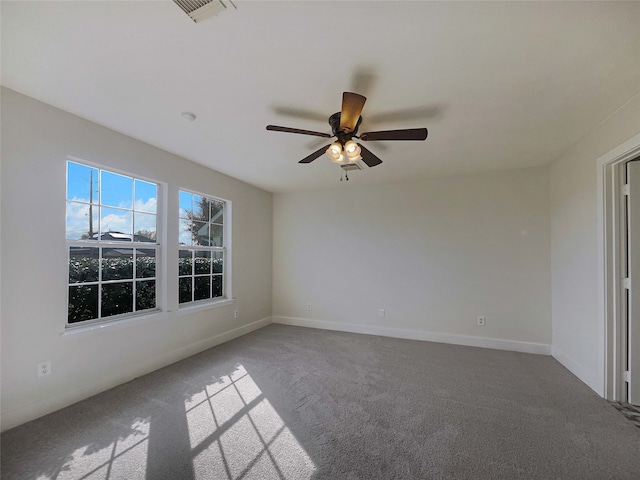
left=176, top=187, right=233, bottom=311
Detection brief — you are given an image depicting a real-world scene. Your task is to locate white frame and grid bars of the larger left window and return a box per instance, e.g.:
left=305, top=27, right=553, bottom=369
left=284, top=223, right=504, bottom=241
left=65, top=156, right=166, bottom=331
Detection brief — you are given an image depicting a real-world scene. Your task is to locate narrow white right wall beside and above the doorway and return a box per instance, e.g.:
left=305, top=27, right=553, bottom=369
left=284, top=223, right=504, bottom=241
left=551, top=95, right=640, bottom=395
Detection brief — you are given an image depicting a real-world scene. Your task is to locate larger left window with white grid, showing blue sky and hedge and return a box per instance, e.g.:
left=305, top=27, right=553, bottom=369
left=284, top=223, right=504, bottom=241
left=66, top=161, right=160, bottom=325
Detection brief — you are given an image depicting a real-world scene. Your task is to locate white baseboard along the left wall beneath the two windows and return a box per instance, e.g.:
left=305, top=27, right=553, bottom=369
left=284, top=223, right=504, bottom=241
left=0, top=317, right=271, bottom=431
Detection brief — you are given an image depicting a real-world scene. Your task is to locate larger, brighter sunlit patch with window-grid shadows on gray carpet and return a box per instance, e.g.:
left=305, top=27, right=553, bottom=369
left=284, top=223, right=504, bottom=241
left=185, top=365, right=316, bottom=480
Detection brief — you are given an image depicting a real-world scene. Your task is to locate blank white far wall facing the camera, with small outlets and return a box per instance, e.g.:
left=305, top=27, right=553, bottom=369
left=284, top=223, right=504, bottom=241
left=273, top=167, right=551, bottom=353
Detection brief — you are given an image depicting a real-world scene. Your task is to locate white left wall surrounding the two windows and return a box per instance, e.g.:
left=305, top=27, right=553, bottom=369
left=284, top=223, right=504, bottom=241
left=1, top=89, right=272, bottom=430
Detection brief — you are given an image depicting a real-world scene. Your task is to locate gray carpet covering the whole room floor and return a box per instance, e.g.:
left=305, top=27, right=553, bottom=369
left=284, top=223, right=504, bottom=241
left=1, top=325, right=640, bottom=480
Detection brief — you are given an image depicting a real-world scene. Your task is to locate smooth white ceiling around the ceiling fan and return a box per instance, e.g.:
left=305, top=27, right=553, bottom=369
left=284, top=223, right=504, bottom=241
left=1, top=0, right=640, bottom=192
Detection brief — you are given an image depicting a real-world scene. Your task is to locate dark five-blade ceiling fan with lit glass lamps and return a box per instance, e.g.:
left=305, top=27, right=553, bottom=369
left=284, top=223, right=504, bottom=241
left=267, top=92, right=428, bottom=168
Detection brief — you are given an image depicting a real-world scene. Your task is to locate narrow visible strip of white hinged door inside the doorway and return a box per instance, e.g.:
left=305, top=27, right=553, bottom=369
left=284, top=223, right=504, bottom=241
left=623, top=161, right=640, bottom=405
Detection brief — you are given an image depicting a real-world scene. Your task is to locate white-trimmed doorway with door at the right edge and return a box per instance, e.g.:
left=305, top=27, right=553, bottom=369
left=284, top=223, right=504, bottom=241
left=598, top=135, right=640, bottom=405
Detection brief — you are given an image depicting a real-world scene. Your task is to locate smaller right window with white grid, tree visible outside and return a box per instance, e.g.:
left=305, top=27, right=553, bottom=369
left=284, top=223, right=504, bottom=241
left=178, top=190, right=228, bottom=304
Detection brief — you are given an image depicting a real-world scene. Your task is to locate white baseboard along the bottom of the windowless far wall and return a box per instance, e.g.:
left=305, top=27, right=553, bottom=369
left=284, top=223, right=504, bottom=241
left=273, top=316, right=551, bottom=355
